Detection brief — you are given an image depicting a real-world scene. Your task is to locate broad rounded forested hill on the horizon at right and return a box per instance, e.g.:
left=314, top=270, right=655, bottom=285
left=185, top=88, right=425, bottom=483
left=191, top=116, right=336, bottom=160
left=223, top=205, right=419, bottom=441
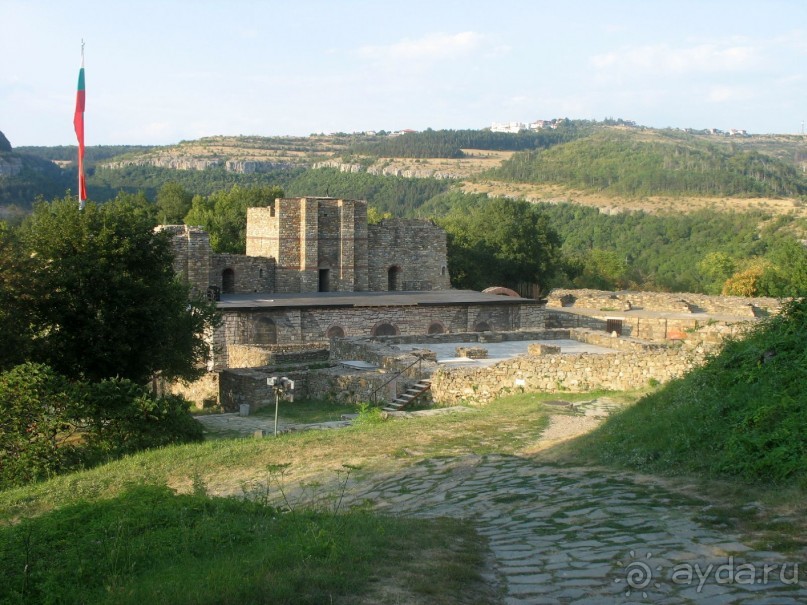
left=487, top=129, right=807, bottom=197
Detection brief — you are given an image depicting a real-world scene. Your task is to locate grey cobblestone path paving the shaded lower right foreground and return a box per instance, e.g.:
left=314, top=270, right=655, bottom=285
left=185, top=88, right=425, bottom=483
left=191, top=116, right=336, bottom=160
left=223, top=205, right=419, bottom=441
left=347, top=456, right=807, bottom=605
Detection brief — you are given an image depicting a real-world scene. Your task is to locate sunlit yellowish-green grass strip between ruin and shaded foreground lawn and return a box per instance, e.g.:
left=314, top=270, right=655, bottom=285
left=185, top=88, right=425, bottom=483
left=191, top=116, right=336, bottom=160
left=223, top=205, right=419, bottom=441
left=0, top=394, right=568, bottom=521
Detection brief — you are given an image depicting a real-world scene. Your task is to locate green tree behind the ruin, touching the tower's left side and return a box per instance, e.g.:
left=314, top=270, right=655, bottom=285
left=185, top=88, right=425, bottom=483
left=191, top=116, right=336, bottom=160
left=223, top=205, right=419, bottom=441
left=185, top=186, right=283, bottom=254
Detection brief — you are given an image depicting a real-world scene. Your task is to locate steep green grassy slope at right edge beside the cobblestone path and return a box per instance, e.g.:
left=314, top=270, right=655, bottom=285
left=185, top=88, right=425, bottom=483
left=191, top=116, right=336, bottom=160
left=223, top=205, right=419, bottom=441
left=576, top=301, right=807, bottom=489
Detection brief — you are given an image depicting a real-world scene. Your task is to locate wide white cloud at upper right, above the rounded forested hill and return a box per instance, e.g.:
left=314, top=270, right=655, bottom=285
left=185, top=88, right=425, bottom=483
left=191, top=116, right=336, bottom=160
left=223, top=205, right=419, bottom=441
left=591, top=43, right=761, bottom=75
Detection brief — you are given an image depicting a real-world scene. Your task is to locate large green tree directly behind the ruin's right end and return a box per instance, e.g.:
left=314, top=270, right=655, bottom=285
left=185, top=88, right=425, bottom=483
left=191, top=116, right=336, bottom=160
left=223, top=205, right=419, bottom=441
left=439, top=198, right=560, bottom=291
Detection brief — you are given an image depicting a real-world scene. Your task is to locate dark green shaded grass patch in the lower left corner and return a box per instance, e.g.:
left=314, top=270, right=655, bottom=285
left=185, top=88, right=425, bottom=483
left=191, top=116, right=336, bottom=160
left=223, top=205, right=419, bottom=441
left=0, top=485, right=489, bottom=604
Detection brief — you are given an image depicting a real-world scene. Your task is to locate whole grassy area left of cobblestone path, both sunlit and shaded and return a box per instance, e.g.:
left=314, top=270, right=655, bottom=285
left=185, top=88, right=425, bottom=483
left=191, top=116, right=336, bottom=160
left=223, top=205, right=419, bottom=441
left=0, top=395, right=568, bottom=604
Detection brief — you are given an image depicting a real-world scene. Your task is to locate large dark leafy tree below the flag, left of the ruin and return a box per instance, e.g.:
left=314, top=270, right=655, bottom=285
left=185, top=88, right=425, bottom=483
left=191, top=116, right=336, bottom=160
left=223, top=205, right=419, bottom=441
left=4, top=197, right=221, bottom=384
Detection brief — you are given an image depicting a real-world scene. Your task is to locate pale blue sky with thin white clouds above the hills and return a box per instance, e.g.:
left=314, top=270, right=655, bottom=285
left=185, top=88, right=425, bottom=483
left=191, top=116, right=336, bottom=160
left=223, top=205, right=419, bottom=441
left=0, top=0, right=807, bottom=146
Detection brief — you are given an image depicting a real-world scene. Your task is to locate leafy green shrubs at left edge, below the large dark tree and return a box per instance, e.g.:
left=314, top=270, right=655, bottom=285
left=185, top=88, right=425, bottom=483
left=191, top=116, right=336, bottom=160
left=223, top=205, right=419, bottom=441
left=0, top=363, right=203, bottom=489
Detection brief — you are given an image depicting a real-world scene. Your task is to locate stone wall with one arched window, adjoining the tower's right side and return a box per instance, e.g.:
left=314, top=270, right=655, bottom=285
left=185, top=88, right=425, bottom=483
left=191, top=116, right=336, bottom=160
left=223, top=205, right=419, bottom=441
left=368, top=218, right=451, bottom=292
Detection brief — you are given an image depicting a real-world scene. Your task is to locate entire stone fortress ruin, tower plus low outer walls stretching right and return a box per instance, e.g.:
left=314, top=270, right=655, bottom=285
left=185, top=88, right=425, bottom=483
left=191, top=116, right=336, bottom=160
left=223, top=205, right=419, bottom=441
left=161, top=197, right=780, bottom=410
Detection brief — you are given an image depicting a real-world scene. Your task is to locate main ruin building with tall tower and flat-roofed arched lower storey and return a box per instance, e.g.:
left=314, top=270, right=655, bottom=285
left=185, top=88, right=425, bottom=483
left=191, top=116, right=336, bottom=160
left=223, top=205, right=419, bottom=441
left=161, top=197, right=544, bottom=370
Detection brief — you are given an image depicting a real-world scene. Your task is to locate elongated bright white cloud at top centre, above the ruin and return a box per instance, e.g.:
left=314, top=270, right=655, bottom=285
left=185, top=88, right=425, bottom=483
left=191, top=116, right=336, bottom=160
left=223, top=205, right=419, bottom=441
left=356, top=31, right=486, bottom=61
